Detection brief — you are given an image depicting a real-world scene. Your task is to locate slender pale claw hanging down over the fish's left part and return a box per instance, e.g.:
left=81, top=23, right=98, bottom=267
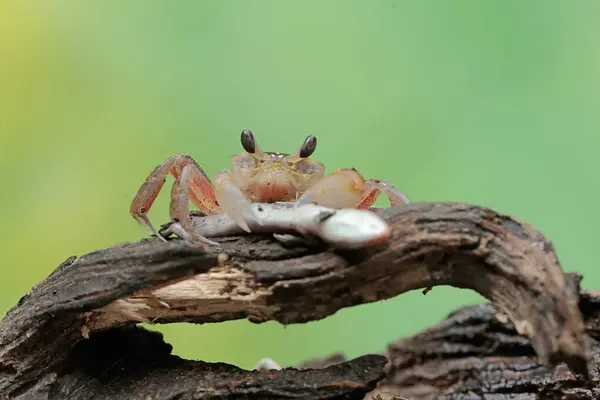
left=215, top=170, right=260, bottom=233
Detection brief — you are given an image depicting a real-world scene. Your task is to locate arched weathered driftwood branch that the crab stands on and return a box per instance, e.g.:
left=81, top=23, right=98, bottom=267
left=0, top=203, right=591, bottom=399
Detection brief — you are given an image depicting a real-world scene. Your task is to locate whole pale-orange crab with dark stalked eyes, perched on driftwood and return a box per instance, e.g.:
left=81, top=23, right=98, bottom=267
left=130, top=129, right=410, bottom=244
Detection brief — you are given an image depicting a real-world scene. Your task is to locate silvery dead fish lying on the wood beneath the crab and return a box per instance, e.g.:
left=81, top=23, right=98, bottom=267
left=160, top=202, right=392, bottom=249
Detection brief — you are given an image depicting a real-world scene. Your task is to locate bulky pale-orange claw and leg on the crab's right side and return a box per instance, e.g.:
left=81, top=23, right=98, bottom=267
left=297, top=168, right=410, bottom=209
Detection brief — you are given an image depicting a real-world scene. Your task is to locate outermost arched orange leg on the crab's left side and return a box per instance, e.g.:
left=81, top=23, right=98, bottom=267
left=129, top=154, right=220, bottom=237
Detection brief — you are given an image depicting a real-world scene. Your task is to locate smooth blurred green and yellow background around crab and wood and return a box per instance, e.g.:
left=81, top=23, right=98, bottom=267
left=0, top=0, right=600, bottom=368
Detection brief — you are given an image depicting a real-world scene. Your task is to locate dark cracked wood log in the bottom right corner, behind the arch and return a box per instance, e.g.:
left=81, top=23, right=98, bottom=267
left=367, top=282, right=600, bottom=400
